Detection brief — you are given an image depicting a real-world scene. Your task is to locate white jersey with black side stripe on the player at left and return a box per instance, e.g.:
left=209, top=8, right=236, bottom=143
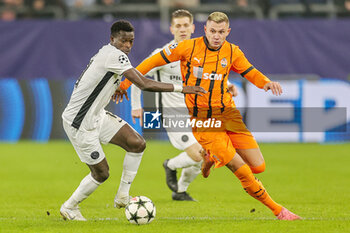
left=62, top=44, right=132, bottom=130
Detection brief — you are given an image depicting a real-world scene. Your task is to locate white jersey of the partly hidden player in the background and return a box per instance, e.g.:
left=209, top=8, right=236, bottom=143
left=131, top=41, right=187, bottom=110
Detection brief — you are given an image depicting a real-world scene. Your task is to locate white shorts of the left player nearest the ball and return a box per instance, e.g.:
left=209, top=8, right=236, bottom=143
left=63, top=111, right=127, bottom=165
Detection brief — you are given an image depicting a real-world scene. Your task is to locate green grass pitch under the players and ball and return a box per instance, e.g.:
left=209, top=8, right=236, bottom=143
left=0, top=141, right=350, bottom=233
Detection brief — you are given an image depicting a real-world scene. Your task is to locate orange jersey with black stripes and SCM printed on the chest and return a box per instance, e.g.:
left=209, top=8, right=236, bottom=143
left=121, top=37, right=270, bottom=118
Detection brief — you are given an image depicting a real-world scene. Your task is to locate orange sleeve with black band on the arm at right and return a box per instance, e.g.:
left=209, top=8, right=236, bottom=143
left=231, top=46, right=271, bottom=88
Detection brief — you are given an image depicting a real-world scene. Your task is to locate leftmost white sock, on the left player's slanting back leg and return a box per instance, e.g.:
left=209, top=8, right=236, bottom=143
left=65, top=173, right=101, bottom=208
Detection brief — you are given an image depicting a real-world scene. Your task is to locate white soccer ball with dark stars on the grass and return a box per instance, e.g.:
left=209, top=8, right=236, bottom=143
left=125, top=196, right=156, bottom=225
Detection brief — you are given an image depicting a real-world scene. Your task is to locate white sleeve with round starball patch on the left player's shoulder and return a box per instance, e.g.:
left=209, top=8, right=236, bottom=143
left=105, top=51, right=133, bottom=75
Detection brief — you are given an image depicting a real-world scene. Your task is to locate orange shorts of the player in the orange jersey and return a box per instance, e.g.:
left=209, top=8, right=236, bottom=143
left=192, top=109, right=259, bottom=168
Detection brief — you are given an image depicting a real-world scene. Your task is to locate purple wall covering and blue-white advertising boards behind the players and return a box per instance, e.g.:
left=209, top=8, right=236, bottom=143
left=0, top=18, right=350, bottom=142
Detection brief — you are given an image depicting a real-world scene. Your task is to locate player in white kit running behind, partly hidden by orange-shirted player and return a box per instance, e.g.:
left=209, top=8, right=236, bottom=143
left=127, top=10, right=239, bottom=201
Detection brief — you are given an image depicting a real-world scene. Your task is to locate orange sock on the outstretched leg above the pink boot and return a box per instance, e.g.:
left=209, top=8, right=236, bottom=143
left=234, top=164, right=282, bottom=215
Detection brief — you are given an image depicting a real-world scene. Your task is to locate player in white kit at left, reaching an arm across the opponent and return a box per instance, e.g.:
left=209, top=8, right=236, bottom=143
left=60, top=20, right=205, bottom=221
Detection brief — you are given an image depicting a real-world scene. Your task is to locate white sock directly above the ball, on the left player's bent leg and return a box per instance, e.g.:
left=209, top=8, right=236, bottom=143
left=117, top=152, right=143, bottom=196
